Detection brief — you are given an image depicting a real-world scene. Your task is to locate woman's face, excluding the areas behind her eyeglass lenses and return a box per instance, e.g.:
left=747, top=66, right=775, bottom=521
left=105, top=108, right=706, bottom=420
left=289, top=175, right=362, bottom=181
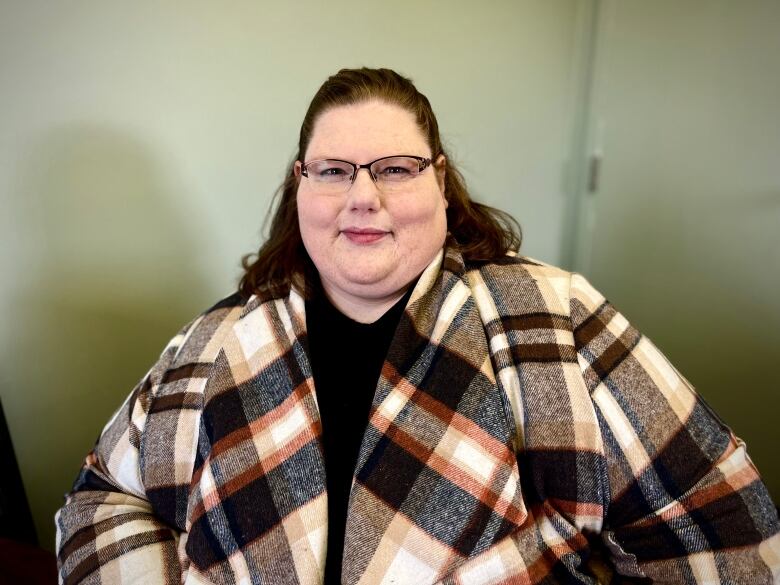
left=298, top=101, right=447, bottom=310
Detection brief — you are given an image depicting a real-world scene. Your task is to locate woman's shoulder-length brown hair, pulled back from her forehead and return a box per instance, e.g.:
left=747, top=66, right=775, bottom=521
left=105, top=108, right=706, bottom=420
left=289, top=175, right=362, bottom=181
left=239, top=67, right=521, bottom=298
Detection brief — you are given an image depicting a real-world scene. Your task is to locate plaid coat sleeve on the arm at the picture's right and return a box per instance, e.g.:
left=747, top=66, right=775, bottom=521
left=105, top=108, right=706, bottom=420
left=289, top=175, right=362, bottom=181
left=571, top=275, right=780, bottom=584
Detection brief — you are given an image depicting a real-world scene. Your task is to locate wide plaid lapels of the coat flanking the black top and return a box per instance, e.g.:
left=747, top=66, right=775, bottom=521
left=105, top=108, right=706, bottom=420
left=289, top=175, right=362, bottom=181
left=187, top=249, right=527, bottom=584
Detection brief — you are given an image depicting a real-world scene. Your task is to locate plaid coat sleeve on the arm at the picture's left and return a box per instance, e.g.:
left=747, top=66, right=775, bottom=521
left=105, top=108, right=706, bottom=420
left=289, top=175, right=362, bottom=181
left=56, top=327, right=198, bottom=584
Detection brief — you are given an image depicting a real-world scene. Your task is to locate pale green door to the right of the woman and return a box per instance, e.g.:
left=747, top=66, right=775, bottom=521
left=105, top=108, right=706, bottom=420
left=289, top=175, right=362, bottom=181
left=574, top=0, right=780, bottom=501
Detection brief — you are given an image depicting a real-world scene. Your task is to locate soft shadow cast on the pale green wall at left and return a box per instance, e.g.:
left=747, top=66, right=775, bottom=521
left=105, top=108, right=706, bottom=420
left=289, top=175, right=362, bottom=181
left=0, top=126, right=214, bottom=550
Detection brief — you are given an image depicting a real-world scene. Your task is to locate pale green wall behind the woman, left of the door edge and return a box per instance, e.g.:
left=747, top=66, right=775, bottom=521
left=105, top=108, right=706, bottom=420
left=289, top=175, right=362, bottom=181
left=0, top=0, right=586, bottom=547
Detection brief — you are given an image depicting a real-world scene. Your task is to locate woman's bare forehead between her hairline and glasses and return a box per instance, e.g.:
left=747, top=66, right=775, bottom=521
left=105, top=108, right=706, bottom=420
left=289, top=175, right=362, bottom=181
left=305, top=101, right=431, bottom=162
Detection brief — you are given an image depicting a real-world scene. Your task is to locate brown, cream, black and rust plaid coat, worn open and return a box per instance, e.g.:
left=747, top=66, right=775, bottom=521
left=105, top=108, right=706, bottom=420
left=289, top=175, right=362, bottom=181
left=57, top=250, right=780, bottom=585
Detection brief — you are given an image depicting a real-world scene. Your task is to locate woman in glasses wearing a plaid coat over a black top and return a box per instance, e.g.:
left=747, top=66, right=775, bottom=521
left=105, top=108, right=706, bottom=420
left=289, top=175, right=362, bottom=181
left=57, top=69, right=780, bottom=585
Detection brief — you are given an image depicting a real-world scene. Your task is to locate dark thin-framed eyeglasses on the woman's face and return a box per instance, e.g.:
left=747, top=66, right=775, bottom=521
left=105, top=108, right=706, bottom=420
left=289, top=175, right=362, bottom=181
left=300, top=154, right=431, bottom=193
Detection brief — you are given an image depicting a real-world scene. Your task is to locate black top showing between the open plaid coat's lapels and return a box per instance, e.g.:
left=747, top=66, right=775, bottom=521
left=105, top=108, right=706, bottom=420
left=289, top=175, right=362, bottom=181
left=306, top=286, right=413, bottom=585
